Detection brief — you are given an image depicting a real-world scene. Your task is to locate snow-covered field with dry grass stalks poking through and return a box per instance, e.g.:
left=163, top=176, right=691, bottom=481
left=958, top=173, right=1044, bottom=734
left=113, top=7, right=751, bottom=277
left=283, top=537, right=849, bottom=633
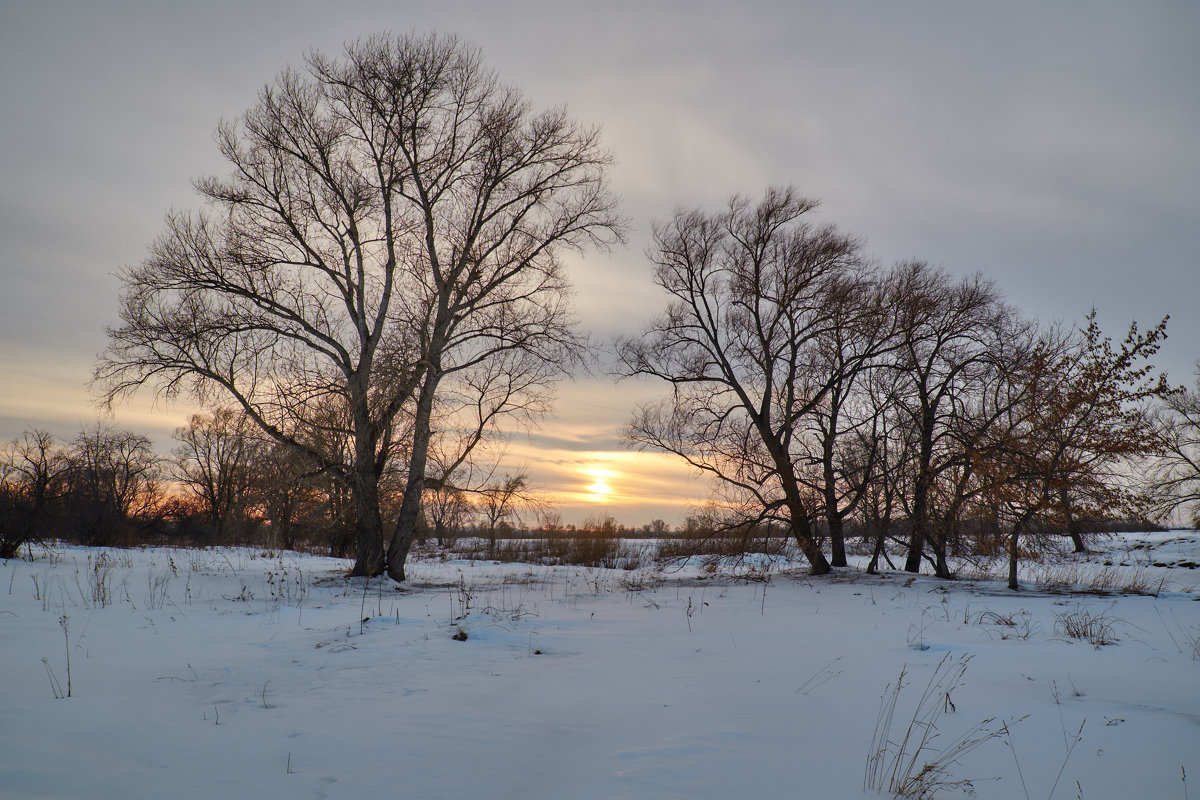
left=0, top=531, right=1200, bottom=800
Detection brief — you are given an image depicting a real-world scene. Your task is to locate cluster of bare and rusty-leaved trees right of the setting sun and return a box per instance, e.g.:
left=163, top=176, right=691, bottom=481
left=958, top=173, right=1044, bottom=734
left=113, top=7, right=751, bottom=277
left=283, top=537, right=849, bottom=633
left=619, top=188, right=1182, bottom=588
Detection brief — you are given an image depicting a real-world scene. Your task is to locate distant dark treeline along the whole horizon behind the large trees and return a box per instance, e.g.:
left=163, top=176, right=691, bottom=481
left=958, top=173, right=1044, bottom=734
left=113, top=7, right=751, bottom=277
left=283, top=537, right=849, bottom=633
left=0, top=411, right=1157, bottom=563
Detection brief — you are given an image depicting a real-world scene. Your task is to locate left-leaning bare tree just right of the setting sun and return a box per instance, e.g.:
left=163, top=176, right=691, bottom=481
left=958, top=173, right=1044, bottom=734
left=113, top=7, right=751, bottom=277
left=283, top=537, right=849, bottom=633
left=619, top=188, right=863, bottom=575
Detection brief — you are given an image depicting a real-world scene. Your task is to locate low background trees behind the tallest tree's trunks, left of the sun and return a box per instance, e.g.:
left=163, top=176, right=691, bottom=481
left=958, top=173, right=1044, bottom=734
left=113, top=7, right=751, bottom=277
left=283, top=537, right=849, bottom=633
left=0, top=408, right=562, bottom=558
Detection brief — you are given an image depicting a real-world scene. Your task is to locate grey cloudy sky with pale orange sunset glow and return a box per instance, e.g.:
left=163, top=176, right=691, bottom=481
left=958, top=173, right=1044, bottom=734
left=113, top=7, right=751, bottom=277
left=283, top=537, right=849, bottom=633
left=0, top=0, right=1200, bottom=524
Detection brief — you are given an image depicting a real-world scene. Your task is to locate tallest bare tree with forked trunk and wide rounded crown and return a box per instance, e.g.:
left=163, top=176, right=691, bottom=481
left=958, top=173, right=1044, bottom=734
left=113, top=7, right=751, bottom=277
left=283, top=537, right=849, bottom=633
left=96, top=35, right=622, bottom=581
